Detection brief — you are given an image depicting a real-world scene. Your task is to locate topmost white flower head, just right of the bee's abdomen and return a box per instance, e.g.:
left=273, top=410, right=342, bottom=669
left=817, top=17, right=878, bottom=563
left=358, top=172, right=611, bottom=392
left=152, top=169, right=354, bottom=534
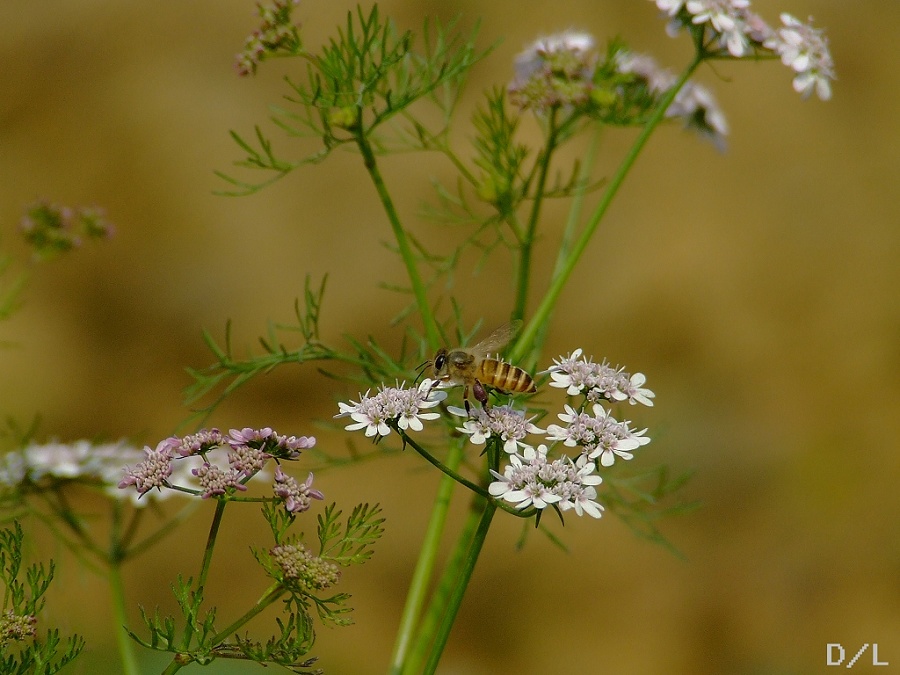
left=545, top=349, right=656, bottom=406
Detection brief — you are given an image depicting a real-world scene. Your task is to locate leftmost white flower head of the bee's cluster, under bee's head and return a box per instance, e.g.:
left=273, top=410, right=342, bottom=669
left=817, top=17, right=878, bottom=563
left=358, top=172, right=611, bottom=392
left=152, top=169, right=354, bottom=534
left=335, top=378, right=447, bottom=437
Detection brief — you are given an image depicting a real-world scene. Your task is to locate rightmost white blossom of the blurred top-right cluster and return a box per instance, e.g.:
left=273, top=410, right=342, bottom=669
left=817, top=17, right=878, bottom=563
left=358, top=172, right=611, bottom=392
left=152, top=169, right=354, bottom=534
left=765, top=13, right=835, bottom=101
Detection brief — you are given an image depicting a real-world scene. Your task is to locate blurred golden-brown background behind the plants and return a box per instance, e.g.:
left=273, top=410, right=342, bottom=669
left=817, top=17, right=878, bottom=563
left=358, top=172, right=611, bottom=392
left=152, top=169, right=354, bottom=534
left=0, top=0, right=900, bottom=675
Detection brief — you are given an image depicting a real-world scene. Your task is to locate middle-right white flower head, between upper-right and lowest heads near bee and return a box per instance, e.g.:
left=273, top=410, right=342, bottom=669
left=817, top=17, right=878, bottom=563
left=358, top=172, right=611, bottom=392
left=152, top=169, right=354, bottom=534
left=547, top=404, right=650, bottom=466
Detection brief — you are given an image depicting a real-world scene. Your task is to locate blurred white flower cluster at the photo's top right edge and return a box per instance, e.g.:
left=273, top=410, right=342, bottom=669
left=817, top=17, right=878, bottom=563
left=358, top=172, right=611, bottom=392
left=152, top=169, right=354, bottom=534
left=654, top=0, right=835, bottom=101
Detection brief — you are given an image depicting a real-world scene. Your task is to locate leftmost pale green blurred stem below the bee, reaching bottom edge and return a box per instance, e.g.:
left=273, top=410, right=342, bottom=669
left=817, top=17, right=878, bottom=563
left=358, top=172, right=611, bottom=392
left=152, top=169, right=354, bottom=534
left=389, top=441, right=464, bottom=675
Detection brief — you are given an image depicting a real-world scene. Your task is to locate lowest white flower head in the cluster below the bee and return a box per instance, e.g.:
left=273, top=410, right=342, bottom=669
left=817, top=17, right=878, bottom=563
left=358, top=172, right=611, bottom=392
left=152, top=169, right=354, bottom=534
left=488, top=445, right=603, bottom=518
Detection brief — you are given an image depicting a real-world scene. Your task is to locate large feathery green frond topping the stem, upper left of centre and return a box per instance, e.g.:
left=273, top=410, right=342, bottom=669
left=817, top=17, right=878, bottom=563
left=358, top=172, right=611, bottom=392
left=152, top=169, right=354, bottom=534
left=217, top=5, right=487, bottom=195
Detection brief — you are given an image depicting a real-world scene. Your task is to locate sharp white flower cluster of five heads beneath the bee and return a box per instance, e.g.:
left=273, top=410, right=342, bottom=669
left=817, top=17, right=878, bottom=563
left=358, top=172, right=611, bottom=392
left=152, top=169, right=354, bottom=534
left=335, top=349, right=654, bottom=518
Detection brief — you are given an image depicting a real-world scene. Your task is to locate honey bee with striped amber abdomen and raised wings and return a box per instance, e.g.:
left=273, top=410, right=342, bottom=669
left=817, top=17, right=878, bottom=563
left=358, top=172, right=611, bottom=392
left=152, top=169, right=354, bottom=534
left=430, top=321, right=537, bottom=412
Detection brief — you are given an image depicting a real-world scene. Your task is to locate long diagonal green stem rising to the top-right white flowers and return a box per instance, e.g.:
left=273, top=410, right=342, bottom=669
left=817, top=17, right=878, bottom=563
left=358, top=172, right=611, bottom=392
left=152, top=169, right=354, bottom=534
left=509, top=53, right=703, bottom=362
